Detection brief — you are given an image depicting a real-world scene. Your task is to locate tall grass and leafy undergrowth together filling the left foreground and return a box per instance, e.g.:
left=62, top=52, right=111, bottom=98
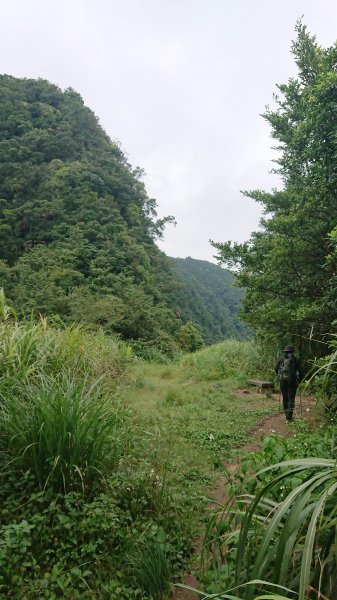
left=0, top=314, right=195, bottom=600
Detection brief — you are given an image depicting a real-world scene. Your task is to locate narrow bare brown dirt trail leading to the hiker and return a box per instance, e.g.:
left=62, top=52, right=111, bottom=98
left=171, top=390, right=315, bottom=600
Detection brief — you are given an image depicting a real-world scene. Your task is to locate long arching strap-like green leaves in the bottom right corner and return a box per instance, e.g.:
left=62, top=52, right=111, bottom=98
left=202, top=458, right=337, bottom=600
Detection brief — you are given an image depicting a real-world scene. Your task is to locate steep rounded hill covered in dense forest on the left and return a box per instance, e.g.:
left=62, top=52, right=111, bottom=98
left=0, top=75, right=243, bottom=353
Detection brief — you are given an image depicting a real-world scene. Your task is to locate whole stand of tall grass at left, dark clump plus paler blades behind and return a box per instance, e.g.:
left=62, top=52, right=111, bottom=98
left=0, top=320, right=131, bottom=492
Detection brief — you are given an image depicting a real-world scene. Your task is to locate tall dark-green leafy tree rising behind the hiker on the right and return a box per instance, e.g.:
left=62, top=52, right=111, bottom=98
left=214, top=22, right=337, bottom=354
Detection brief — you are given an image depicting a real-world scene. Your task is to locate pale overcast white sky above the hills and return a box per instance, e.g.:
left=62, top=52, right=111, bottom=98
left=0, top=0, right=337, bottom=262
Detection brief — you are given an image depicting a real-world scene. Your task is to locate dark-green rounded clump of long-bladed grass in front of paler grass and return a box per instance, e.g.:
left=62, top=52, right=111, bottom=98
left=0, top=373, right=123, bottom=492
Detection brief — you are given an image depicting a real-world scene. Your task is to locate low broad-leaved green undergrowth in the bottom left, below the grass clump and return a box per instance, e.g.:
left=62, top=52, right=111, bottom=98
left=0, top=476, right=176, bottom=600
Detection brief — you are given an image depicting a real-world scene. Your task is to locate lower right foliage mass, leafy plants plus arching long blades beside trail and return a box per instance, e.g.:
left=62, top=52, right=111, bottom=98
left=201, top=424, right=336, bottom=599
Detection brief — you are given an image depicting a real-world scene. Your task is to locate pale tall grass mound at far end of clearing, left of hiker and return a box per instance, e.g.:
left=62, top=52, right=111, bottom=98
left=181, top=339, right=274, bottom=381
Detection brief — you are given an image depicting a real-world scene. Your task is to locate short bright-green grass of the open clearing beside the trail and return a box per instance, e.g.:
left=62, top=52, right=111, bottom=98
left=120, top=363, right=277, bottom=497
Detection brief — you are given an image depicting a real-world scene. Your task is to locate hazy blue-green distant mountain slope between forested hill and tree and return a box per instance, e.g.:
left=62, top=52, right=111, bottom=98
left=170, top=257, right=249, bottom=344
